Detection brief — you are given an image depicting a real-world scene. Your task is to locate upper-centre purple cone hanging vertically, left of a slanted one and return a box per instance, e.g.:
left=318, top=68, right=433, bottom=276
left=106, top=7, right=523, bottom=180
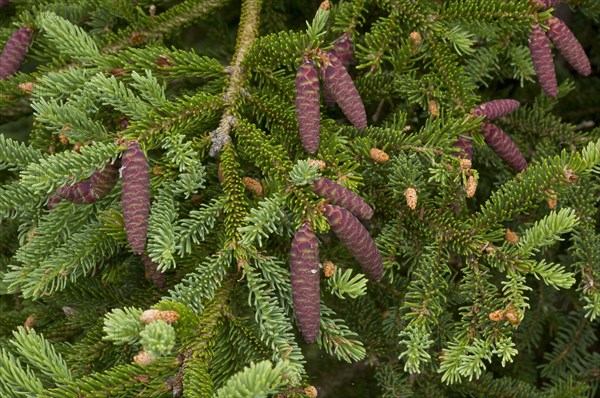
left=296, top=58, right=321, bottom=154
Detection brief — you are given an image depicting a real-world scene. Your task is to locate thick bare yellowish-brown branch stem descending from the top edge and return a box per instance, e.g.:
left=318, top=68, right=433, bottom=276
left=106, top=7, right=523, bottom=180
left=210, top=0, right=262, bottom=156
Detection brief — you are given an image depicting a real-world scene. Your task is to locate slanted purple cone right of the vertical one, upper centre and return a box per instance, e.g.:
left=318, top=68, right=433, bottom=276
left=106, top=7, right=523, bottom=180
left=322, top=53, right=367, bottom=130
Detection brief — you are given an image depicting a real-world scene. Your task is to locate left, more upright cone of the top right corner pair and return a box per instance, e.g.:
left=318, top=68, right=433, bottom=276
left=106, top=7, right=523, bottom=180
left=529, top=24, right=558, bottom=98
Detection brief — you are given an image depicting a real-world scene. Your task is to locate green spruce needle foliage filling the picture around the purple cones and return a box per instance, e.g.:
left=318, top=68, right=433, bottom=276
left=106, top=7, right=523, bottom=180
left=0, top=0, right=600, bottom=397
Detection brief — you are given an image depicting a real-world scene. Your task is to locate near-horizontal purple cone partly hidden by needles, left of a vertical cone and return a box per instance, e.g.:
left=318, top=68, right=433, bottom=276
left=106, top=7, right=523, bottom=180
left=55, top=160, right=120, bottom=204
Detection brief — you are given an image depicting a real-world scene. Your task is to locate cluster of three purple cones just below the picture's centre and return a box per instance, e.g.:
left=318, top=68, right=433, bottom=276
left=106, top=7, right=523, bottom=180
left=290, top=178, right=383, bottom=343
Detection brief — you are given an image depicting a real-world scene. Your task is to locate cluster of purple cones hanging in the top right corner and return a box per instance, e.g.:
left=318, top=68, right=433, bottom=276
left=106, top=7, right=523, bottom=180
left=529, top=0, right=592, bottom=98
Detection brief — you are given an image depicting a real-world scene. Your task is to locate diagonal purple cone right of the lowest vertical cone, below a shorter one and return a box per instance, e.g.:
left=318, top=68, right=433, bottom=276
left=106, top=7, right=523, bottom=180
left=324, top=205, right=383, bottom=281
